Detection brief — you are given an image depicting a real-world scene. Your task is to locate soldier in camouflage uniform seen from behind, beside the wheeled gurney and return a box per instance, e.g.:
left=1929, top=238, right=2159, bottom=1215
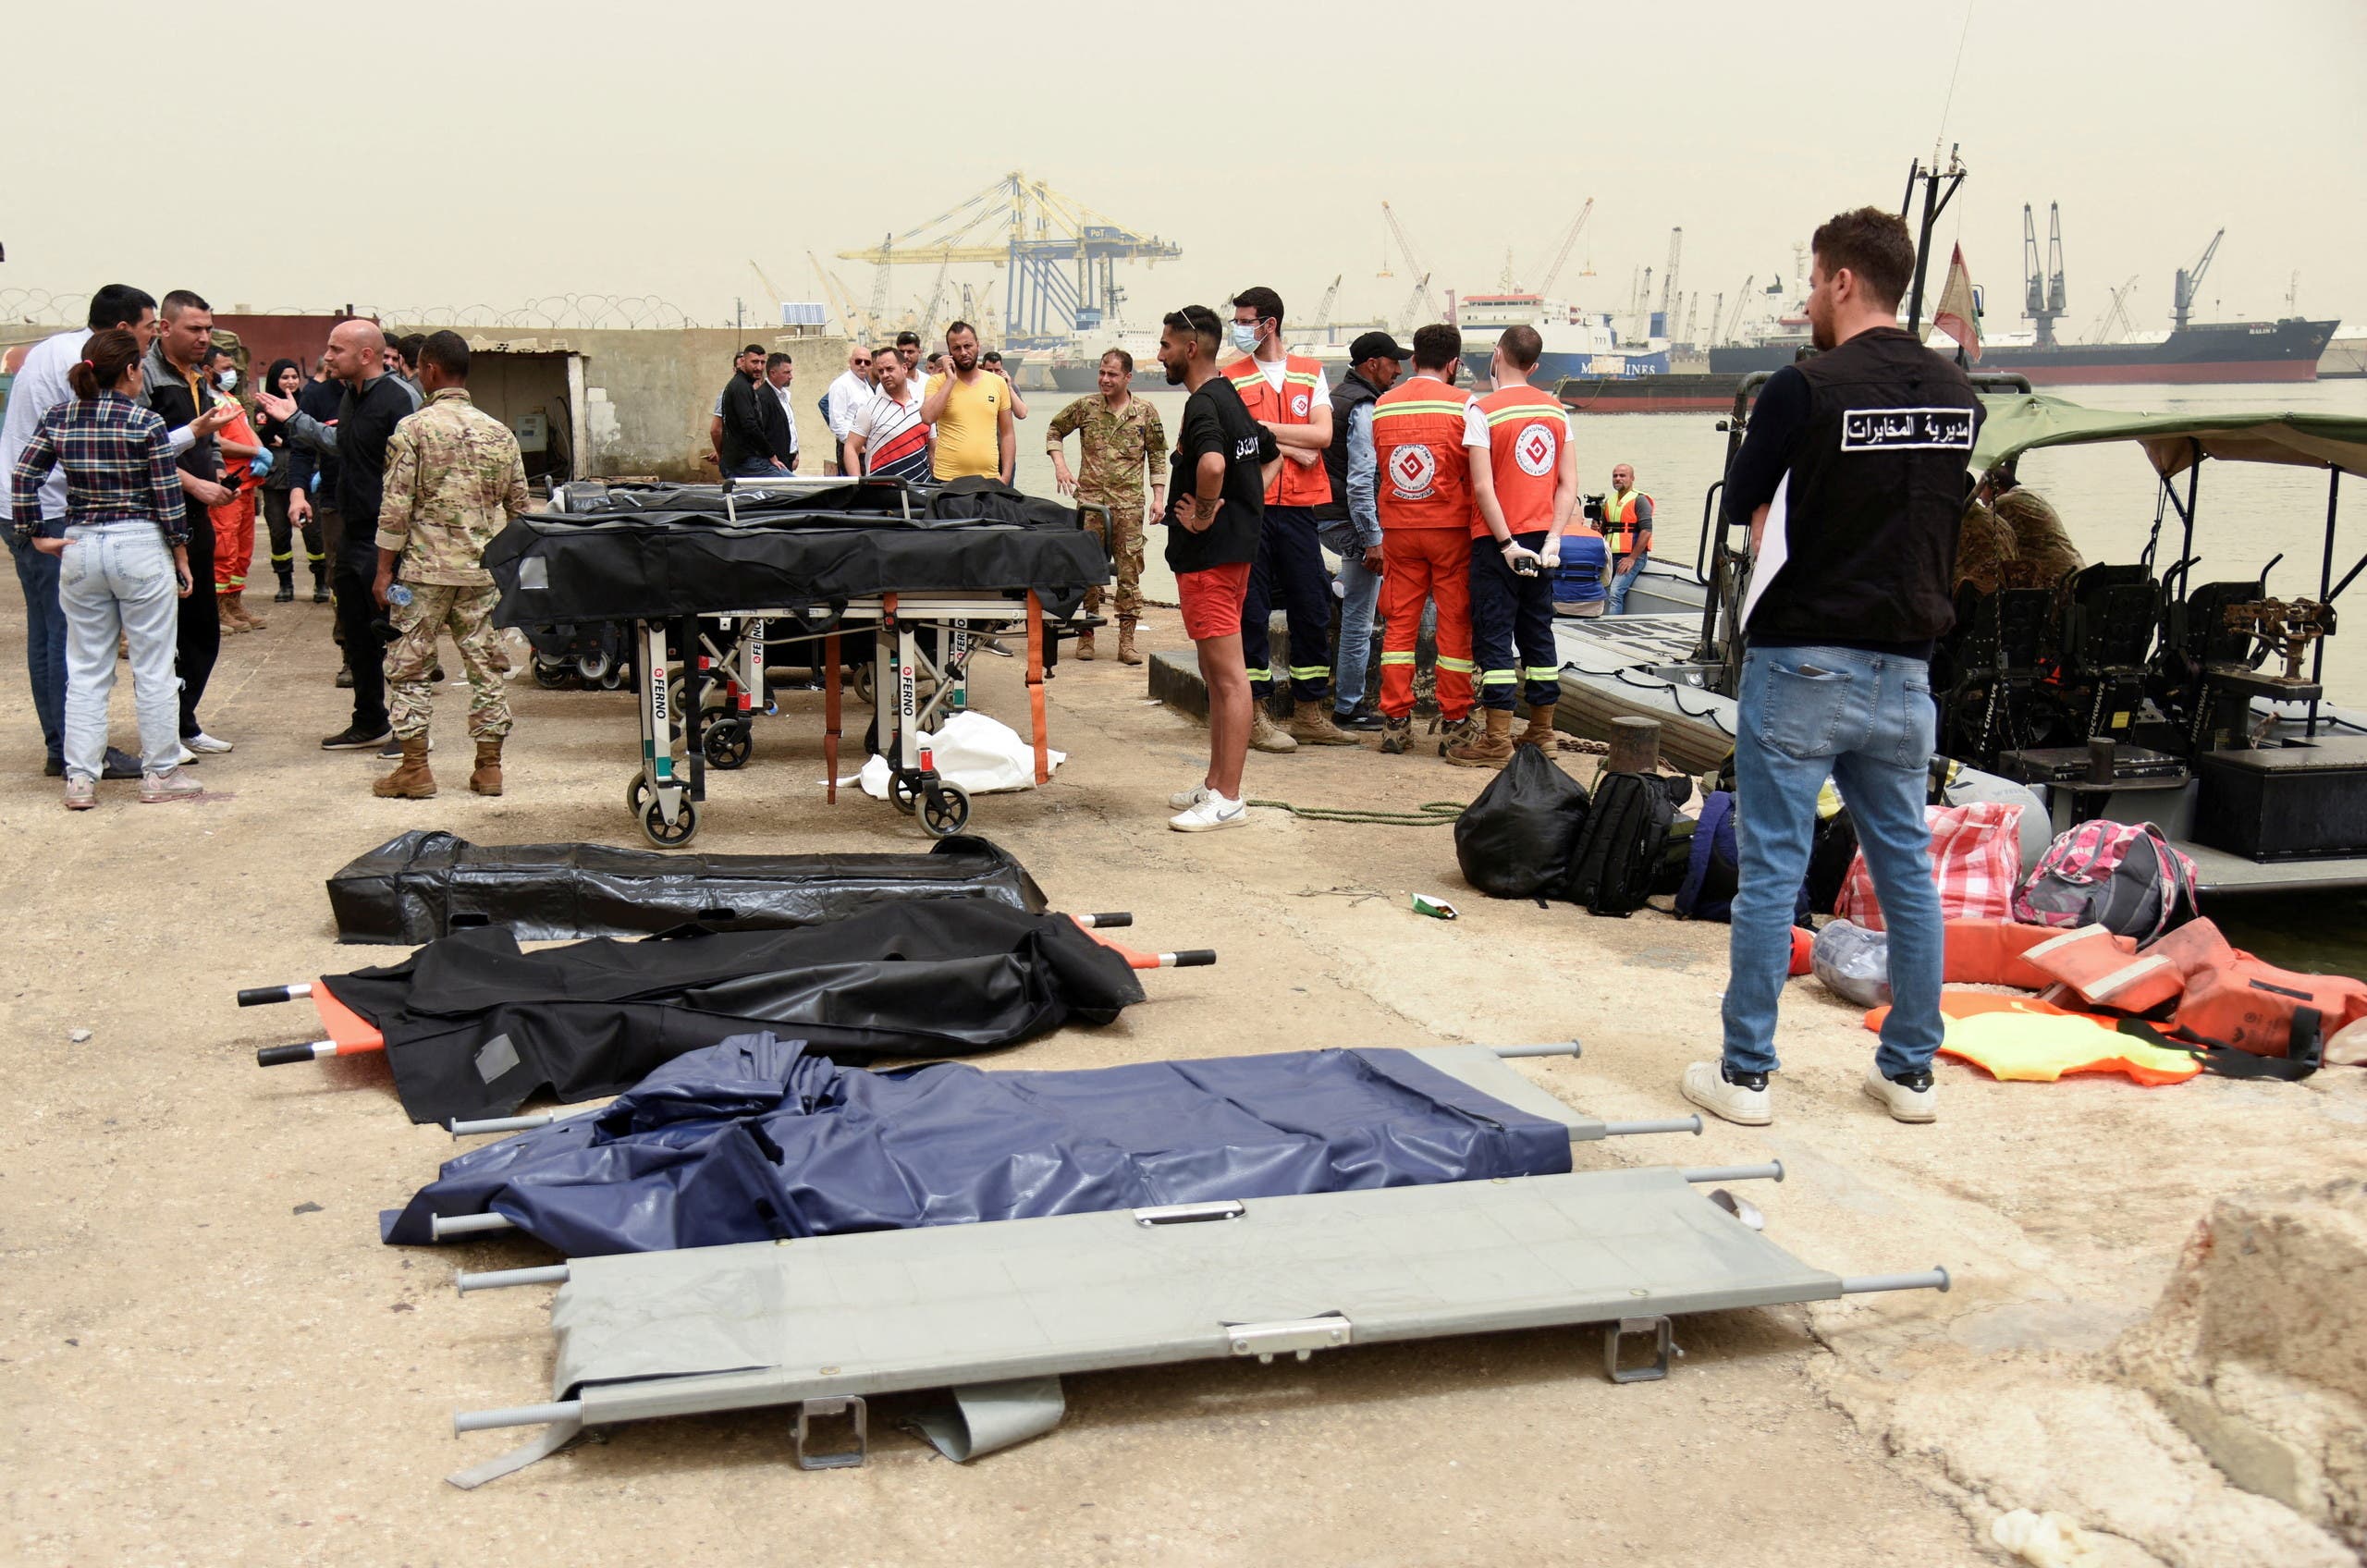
left=372, top=332, right=528, bottom=801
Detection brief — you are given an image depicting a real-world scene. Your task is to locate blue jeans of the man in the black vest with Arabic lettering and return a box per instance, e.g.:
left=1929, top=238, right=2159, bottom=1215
left=1725, top=646, right=1945, bottom=1078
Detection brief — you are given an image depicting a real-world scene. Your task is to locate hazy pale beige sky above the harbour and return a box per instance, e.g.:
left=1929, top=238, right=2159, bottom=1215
left=0, top=0, right=2367, bottom=337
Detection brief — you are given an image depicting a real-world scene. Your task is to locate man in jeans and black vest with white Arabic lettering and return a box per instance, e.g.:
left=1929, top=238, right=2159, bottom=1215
left=1681, top=206, right=1981, bottom=1127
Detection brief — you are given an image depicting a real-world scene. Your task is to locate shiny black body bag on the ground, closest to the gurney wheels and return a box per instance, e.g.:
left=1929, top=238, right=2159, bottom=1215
left=329, top=829, right=1044, bottom=948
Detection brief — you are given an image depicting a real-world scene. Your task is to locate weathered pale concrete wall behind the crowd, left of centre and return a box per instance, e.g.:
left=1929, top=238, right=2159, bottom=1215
left=457, top=327, right=847, bottom=479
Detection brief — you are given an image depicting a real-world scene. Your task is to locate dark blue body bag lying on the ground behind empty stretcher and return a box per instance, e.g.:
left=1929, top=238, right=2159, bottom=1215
left=381, top=1033, right=1569, bottom=1257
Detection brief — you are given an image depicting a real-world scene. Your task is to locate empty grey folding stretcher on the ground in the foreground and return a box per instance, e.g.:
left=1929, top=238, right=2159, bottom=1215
left=452, top=1136, right=1948, bottom=1488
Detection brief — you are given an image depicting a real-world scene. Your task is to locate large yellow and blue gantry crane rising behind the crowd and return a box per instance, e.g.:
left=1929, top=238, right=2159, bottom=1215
left=838, top=170, right=1184, bottom=349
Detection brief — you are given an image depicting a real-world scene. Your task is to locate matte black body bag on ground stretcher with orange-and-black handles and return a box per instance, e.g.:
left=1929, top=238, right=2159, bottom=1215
left=320, top=898, right=1143, bottom=1122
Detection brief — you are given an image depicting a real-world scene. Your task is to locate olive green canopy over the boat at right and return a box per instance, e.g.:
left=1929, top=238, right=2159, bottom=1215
left=1971, top=393, right=2367, bottom=479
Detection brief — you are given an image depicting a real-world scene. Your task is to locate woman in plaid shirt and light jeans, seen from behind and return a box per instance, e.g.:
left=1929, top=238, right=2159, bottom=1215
left=9, top=327, right=202, bottom=810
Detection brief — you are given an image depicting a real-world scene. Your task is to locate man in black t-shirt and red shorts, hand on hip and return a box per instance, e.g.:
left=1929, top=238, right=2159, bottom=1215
left=1159, top=305, right=1283, bottom=834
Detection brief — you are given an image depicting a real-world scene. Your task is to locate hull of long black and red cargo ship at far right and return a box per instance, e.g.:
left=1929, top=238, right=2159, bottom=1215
left=1709, top=317, right=2338, bottom=386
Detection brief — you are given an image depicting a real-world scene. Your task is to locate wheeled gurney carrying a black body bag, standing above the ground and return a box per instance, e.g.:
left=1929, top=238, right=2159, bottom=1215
left=485, top=479, right=1110, bottom=848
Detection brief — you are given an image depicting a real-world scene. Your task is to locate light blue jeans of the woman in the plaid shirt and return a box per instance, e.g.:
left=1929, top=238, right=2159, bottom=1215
left=56, top=517, right=180, bottom=779
